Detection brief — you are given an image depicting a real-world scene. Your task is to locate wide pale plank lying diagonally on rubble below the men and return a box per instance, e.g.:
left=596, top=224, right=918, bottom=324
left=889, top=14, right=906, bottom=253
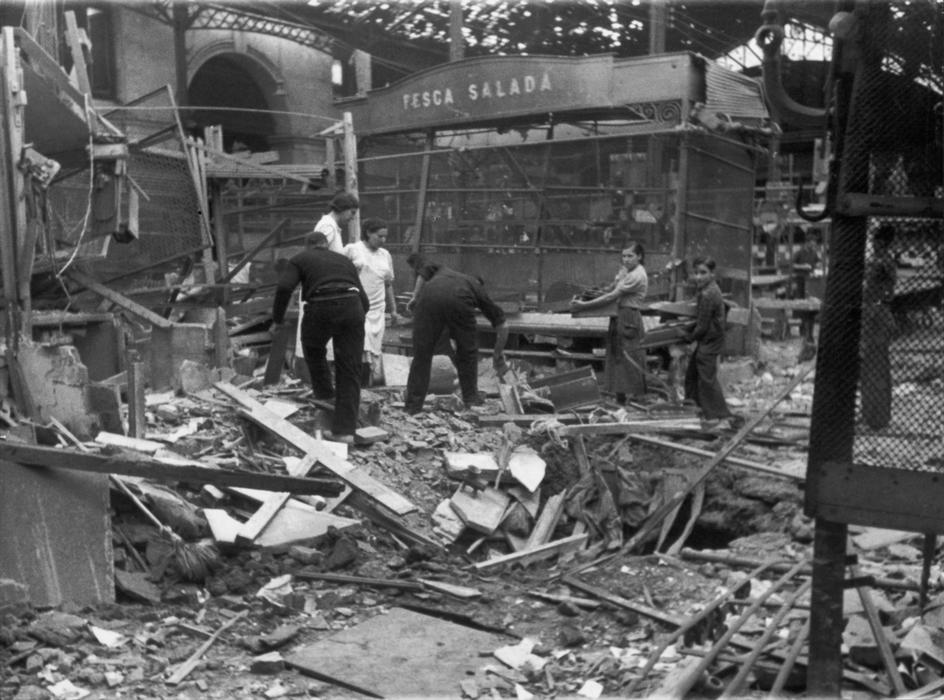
left=213, top=382, right=416, bottom=515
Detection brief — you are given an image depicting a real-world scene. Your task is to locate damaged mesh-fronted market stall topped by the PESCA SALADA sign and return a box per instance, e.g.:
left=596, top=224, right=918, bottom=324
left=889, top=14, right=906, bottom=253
left=344, top=53, right=770, bottom=307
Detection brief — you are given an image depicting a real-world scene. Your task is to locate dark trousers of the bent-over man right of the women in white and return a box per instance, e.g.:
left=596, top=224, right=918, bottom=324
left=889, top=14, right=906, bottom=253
left=404, top=294, right=478, bottom=413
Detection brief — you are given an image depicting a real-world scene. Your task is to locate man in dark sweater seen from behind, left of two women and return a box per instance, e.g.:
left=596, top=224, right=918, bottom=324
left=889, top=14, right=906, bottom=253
left=272, top=232, right=370, bottom=443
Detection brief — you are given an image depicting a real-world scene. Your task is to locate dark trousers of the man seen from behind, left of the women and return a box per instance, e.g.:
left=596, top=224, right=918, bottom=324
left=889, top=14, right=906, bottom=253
left=302, top=293, right=364, bottom=435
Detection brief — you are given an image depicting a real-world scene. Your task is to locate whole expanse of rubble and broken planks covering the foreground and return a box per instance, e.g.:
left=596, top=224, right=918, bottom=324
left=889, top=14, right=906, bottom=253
left=0, top=342, right=944, bottom=698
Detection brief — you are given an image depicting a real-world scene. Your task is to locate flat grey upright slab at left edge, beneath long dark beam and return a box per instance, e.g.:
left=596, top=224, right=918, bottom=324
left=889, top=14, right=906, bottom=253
left=0, top=460, right=115, bottom=607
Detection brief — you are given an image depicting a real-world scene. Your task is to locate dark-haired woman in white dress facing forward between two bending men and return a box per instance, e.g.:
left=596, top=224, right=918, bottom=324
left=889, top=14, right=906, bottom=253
left=344, top=219, right=398, bottom=385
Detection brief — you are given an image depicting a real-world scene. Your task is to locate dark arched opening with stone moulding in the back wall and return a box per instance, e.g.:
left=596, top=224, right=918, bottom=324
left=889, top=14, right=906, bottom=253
left=187, top=42, right=286, bottom=152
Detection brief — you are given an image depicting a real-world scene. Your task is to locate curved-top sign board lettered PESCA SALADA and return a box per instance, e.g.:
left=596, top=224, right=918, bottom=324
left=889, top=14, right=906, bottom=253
left=342, top=56, right=613, bottom=134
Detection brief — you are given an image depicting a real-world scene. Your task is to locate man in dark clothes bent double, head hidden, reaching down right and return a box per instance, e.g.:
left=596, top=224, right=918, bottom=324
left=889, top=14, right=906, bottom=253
left=405, top=267, right=508, bottom=413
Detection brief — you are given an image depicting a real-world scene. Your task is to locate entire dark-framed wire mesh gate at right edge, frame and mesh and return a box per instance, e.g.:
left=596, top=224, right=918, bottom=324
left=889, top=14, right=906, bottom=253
left=807, top=2, right=944, bottom=532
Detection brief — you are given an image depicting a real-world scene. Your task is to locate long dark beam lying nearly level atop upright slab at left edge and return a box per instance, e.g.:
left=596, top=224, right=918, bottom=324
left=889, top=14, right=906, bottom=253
left=0, top=442, right=344, bottom=496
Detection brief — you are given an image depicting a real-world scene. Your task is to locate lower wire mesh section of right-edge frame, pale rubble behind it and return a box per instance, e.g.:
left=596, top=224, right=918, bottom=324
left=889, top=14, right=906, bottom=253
left=854, top=220, right=944, bottom=470
